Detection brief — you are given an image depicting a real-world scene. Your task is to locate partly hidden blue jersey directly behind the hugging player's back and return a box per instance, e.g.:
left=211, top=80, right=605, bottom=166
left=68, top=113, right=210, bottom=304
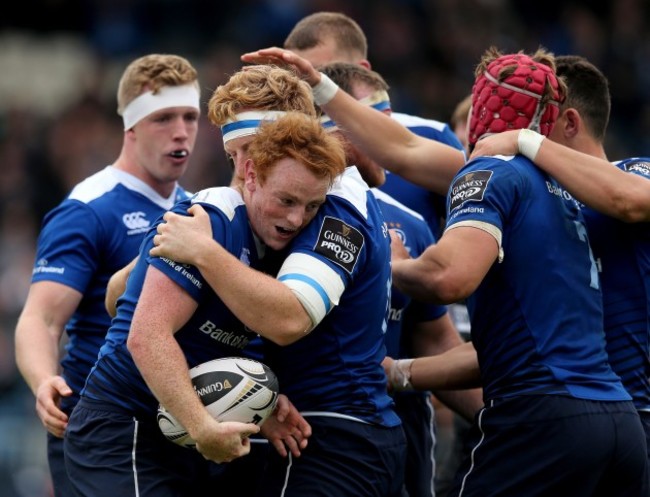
left=371, top=188, right=447, bottom=359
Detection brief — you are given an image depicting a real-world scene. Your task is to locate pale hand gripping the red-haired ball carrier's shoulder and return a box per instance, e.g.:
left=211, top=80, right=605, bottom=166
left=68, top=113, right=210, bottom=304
left=149, top=204, right=213, bottom=265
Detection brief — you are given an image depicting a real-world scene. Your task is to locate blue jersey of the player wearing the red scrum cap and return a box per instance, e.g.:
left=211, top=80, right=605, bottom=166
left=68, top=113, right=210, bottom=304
left=446, top=156, right=630, bottom=400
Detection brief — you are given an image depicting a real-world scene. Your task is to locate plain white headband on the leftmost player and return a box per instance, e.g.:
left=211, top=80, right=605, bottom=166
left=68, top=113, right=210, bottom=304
left=122, top=85, right=201, bottom=131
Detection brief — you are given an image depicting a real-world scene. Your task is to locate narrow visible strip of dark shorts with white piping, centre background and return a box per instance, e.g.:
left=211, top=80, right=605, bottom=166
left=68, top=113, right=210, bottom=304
left=393, top=392, right=436, bottom=497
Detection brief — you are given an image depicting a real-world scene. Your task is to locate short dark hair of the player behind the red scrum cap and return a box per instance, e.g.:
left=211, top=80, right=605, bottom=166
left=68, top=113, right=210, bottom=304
left=555, top=55, right=612, bottom=141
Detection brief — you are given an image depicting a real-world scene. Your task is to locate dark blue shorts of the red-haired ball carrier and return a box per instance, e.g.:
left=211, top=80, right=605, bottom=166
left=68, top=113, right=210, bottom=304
left=64, top=398, right=215, bottom=497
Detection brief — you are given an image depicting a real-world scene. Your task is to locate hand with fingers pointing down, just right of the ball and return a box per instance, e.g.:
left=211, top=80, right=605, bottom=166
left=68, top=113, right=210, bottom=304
left=261, top=394, right=311, bottom=457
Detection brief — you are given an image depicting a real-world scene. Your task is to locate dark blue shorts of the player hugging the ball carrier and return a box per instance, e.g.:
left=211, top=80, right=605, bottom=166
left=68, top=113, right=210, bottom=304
left=258, top=415, right=406, bottom=497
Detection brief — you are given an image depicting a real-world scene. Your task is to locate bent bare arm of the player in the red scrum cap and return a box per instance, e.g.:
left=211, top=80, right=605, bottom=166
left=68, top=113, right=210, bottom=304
left=392, top=226, right=499, bottom=304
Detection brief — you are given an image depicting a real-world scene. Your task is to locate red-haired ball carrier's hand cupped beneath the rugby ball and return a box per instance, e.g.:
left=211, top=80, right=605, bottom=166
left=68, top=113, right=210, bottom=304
left=192, top=420, right=260, bottom=463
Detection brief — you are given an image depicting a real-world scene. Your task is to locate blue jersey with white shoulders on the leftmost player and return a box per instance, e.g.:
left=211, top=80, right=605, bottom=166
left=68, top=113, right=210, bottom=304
left=32, top=166, right=188, bottom=411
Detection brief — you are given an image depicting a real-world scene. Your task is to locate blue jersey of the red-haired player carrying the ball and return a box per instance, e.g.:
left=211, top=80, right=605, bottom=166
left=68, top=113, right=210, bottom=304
left=82, top=187, right=259, bottom=416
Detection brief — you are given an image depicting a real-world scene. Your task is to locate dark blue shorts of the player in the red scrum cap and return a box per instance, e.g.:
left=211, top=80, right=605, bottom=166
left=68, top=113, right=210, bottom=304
left=451, top=395, right=649, bottom=497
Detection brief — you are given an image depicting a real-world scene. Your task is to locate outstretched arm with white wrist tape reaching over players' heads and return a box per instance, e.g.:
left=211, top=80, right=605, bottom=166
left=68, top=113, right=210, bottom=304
left=242, top=48, right=465, bottom=195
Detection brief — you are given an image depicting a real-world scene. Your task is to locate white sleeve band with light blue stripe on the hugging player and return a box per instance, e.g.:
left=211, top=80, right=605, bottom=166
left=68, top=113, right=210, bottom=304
left=278, top=253, right=345, bottom=331
